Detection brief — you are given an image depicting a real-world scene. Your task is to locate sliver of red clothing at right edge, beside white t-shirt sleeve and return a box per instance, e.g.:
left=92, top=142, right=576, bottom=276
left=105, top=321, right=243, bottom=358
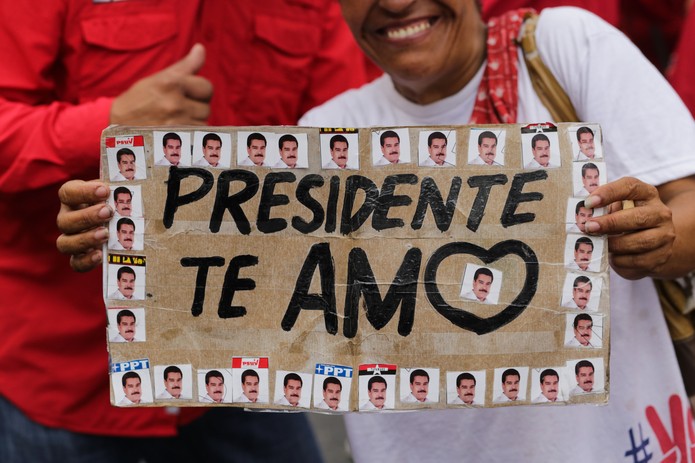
left=669, top=8, right=695, bottom=116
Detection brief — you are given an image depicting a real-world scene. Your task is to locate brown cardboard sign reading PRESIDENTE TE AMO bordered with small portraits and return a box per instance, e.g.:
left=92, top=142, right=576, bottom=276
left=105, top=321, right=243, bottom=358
left=102, top=123, right=610, bottom=413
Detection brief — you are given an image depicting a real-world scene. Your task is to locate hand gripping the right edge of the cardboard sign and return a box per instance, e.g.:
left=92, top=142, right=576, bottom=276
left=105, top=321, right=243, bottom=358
left=584, top=177, right=676, bottom=280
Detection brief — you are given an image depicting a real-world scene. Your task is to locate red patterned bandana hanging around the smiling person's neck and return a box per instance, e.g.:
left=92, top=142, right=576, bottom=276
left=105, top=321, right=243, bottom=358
left=470, top=8, right=533, bottom=124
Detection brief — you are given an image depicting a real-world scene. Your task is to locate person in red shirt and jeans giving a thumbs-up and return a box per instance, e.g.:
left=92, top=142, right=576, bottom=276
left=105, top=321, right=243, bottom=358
left=0, top=0, right=364, bottom=462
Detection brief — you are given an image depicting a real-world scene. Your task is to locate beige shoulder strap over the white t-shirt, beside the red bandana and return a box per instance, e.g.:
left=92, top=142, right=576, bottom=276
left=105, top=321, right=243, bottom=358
left=517, top=13, right=580, bottom=122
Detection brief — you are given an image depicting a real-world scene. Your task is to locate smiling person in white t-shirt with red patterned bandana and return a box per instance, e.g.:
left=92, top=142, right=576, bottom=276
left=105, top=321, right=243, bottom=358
left=300, top=0, right=695, bottom=462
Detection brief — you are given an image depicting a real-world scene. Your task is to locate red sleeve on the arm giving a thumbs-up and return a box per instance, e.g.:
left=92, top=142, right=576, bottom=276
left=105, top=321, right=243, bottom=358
left=0, top=1, right=112, bottom=193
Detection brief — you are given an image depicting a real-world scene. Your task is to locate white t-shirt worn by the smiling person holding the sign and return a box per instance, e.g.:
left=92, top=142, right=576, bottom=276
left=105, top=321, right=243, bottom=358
left=300, top=8, right=695, bottom=462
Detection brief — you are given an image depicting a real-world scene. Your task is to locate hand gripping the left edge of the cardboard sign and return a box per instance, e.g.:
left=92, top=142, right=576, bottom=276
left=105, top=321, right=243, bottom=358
left=56, top=180, right=113, bottom=272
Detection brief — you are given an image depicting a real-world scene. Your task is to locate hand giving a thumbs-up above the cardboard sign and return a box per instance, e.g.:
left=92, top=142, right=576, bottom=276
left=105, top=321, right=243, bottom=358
left=111, top=44, right=212, bottom=125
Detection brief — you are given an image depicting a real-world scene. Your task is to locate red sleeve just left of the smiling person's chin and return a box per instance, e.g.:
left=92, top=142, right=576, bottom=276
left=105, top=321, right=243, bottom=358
left=300, top=1, right=376, bottom=115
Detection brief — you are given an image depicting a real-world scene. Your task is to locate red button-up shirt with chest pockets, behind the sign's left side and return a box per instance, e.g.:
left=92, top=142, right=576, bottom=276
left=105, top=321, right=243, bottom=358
left=0, top=0, right=364, bottom=436
